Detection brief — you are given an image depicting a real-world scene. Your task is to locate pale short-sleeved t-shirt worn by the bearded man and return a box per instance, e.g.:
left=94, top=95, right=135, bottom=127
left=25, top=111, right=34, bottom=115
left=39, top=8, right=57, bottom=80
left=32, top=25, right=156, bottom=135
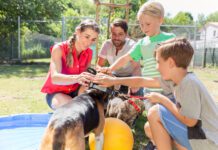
left=98, top=38, right=135, bottom=76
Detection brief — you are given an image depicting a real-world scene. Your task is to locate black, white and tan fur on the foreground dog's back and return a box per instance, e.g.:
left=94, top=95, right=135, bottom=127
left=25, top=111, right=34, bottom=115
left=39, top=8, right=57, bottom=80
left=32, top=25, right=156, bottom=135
left=40, top=89, right=108, bottom=150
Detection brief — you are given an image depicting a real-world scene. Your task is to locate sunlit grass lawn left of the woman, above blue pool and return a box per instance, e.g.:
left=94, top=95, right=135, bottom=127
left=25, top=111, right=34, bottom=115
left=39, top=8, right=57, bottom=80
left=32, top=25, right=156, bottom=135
left=0, top=65, right=51, bottom=116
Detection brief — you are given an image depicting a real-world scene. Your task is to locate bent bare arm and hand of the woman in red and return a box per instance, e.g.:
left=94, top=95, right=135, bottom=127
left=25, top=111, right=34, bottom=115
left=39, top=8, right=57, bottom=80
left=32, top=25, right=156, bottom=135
left=50, top=45, right=92, bottom=86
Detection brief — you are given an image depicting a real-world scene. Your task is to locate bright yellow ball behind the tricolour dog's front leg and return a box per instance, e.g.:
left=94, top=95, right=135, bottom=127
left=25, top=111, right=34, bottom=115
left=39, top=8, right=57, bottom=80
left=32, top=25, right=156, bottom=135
left=89, top=118, right=134, bottom=150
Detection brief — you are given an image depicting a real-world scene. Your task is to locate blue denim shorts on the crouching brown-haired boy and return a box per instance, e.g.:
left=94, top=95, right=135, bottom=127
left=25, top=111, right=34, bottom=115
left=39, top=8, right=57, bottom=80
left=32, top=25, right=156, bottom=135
left=158, top=104, right=192, bottom=150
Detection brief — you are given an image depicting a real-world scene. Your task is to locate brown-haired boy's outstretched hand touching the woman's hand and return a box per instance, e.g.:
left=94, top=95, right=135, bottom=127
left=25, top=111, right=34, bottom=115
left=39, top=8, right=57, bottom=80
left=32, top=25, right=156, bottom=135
left=93, top=73, right=115, bottom=87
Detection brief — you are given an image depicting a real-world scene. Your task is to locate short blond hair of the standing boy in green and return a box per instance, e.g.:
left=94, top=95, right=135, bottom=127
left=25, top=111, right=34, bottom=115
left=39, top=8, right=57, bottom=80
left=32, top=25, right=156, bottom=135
left=137, top=1, right=164, bottom=19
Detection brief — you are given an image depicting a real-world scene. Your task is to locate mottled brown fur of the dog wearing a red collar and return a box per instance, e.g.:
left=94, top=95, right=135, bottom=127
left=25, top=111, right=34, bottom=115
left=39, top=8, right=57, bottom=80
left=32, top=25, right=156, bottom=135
left=106, top=94, right=145, bottom=127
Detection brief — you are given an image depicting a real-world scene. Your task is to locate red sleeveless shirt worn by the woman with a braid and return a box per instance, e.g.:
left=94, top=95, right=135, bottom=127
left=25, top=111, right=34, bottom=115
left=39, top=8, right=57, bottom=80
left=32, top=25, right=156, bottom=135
left=41, top=41, right=92, bottom=94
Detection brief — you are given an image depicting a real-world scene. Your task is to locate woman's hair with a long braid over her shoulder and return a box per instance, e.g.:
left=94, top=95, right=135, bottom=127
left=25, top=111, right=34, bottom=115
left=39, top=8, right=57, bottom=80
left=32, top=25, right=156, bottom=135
left=67, top=19, right=100, bottom=67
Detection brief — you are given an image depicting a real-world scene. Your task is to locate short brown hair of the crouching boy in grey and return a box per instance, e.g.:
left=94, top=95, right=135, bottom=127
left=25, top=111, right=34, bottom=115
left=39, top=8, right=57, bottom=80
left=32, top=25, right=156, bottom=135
left=154, top=38, right=194, bottom=69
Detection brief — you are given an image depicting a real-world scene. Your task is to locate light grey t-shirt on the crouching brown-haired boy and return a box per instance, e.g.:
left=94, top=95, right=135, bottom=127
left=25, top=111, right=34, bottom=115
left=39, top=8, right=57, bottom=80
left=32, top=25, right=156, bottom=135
left=160, top=73, right=218, bottom=149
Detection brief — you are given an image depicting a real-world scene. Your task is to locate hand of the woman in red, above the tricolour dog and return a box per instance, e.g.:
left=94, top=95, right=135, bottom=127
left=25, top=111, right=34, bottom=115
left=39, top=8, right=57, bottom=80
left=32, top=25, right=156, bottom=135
left=77, top=72, right=95, bottom=87
